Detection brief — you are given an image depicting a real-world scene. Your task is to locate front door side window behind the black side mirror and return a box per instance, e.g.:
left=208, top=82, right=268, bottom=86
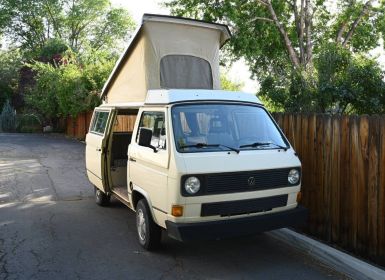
left=136, top=112, right=166, bottom=150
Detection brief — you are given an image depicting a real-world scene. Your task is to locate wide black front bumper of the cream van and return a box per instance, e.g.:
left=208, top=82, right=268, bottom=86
left=166, top=206, right=307, bottom=241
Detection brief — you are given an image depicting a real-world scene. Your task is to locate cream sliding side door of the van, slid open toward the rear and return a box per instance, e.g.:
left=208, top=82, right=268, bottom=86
left=86, top=108, right=115, bottom=192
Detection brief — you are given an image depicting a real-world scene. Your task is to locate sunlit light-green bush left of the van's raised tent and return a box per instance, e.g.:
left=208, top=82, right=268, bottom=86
left=26, top=51, right=116, bottom=121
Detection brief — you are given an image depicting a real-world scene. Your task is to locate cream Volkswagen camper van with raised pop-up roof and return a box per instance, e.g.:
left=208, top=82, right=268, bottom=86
left=86, top=14, right=306, bottom=250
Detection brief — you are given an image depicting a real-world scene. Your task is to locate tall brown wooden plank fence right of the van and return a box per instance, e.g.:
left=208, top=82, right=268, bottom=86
left=274, top=114, right=385, bottom=266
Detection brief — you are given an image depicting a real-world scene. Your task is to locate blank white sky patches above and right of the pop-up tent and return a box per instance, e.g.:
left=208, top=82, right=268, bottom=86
left=111, top=0, right=259, bottom=94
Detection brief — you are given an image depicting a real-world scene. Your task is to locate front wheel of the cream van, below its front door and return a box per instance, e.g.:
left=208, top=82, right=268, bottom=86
left=136, top=199, right=162, bottom=251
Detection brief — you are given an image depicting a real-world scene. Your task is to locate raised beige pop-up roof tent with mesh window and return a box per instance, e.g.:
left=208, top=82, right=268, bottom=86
left=101, top=14, right=231, bottom=103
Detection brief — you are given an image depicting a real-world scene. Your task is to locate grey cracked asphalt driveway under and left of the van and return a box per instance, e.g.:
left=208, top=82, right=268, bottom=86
left=0, top=134, right=345, bottom=279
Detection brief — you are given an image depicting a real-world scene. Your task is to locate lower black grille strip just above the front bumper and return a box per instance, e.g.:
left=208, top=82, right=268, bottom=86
left=201, top=194, right=288, bottom=217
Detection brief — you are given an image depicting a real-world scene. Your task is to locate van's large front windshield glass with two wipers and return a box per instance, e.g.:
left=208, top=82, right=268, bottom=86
left=172, top=104, right=288, bottom=153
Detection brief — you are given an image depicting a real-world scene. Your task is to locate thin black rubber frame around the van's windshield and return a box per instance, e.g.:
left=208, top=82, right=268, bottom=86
left=170, top=100, right=291, bottom=153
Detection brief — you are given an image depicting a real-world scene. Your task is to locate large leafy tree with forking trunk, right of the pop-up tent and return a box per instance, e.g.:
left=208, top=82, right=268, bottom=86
left=166, top=0, right=385, bottom=114
